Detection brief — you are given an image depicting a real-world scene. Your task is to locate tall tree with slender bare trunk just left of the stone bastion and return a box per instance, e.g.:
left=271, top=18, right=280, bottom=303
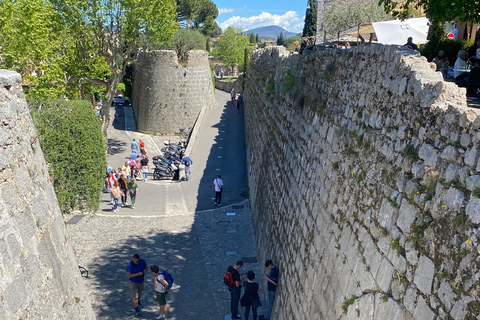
left=51, top=0, right=178, bottom=136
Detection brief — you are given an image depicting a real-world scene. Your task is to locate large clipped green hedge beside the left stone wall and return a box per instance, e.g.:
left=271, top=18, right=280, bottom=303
left=30, top=100, right=106, bottom=213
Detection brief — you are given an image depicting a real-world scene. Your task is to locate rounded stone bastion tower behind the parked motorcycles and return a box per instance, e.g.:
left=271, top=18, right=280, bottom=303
left=133, top=50, right=215, bottom=133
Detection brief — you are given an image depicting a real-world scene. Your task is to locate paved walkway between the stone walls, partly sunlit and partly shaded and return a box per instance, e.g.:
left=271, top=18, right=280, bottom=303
left=66, top=91, right=266, bottom=320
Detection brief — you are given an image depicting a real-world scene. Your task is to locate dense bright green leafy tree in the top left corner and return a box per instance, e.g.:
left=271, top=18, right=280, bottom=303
left=0, top=0, right=71, bottom=98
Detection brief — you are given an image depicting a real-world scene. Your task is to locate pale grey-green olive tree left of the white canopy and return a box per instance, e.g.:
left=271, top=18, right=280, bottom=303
left=323, top=0, right=392, bottom=36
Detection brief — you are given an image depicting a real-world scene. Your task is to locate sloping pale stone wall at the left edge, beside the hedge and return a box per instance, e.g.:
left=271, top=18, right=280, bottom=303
left=0, top=70, right=95, bottom=319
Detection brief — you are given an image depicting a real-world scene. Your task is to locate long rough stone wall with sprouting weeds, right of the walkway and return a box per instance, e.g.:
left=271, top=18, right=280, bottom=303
left=244, top=45, right=480, bottom=320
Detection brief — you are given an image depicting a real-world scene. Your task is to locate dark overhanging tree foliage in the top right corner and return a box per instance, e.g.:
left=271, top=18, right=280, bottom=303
left=379, top=0, right=480, bottom=23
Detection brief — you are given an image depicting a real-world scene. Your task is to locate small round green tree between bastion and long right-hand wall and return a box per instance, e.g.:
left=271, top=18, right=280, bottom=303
left=212, top=27, right=250, bottom=69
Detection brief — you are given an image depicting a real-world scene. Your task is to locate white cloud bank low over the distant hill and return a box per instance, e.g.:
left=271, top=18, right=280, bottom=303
left=220, top=11, right=304, bottom=32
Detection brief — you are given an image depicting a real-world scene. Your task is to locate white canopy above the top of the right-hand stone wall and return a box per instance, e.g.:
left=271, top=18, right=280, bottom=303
left=372, top=18, right=429, bottom=45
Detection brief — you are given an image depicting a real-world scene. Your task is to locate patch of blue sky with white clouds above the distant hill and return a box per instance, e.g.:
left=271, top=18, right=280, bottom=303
left=212, top=0, right=307, bottom=32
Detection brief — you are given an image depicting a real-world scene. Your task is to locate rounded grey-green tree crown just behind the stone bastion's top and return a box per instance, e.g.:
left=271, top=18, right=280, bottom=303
left=169, top=28, right=206, bottom=62
